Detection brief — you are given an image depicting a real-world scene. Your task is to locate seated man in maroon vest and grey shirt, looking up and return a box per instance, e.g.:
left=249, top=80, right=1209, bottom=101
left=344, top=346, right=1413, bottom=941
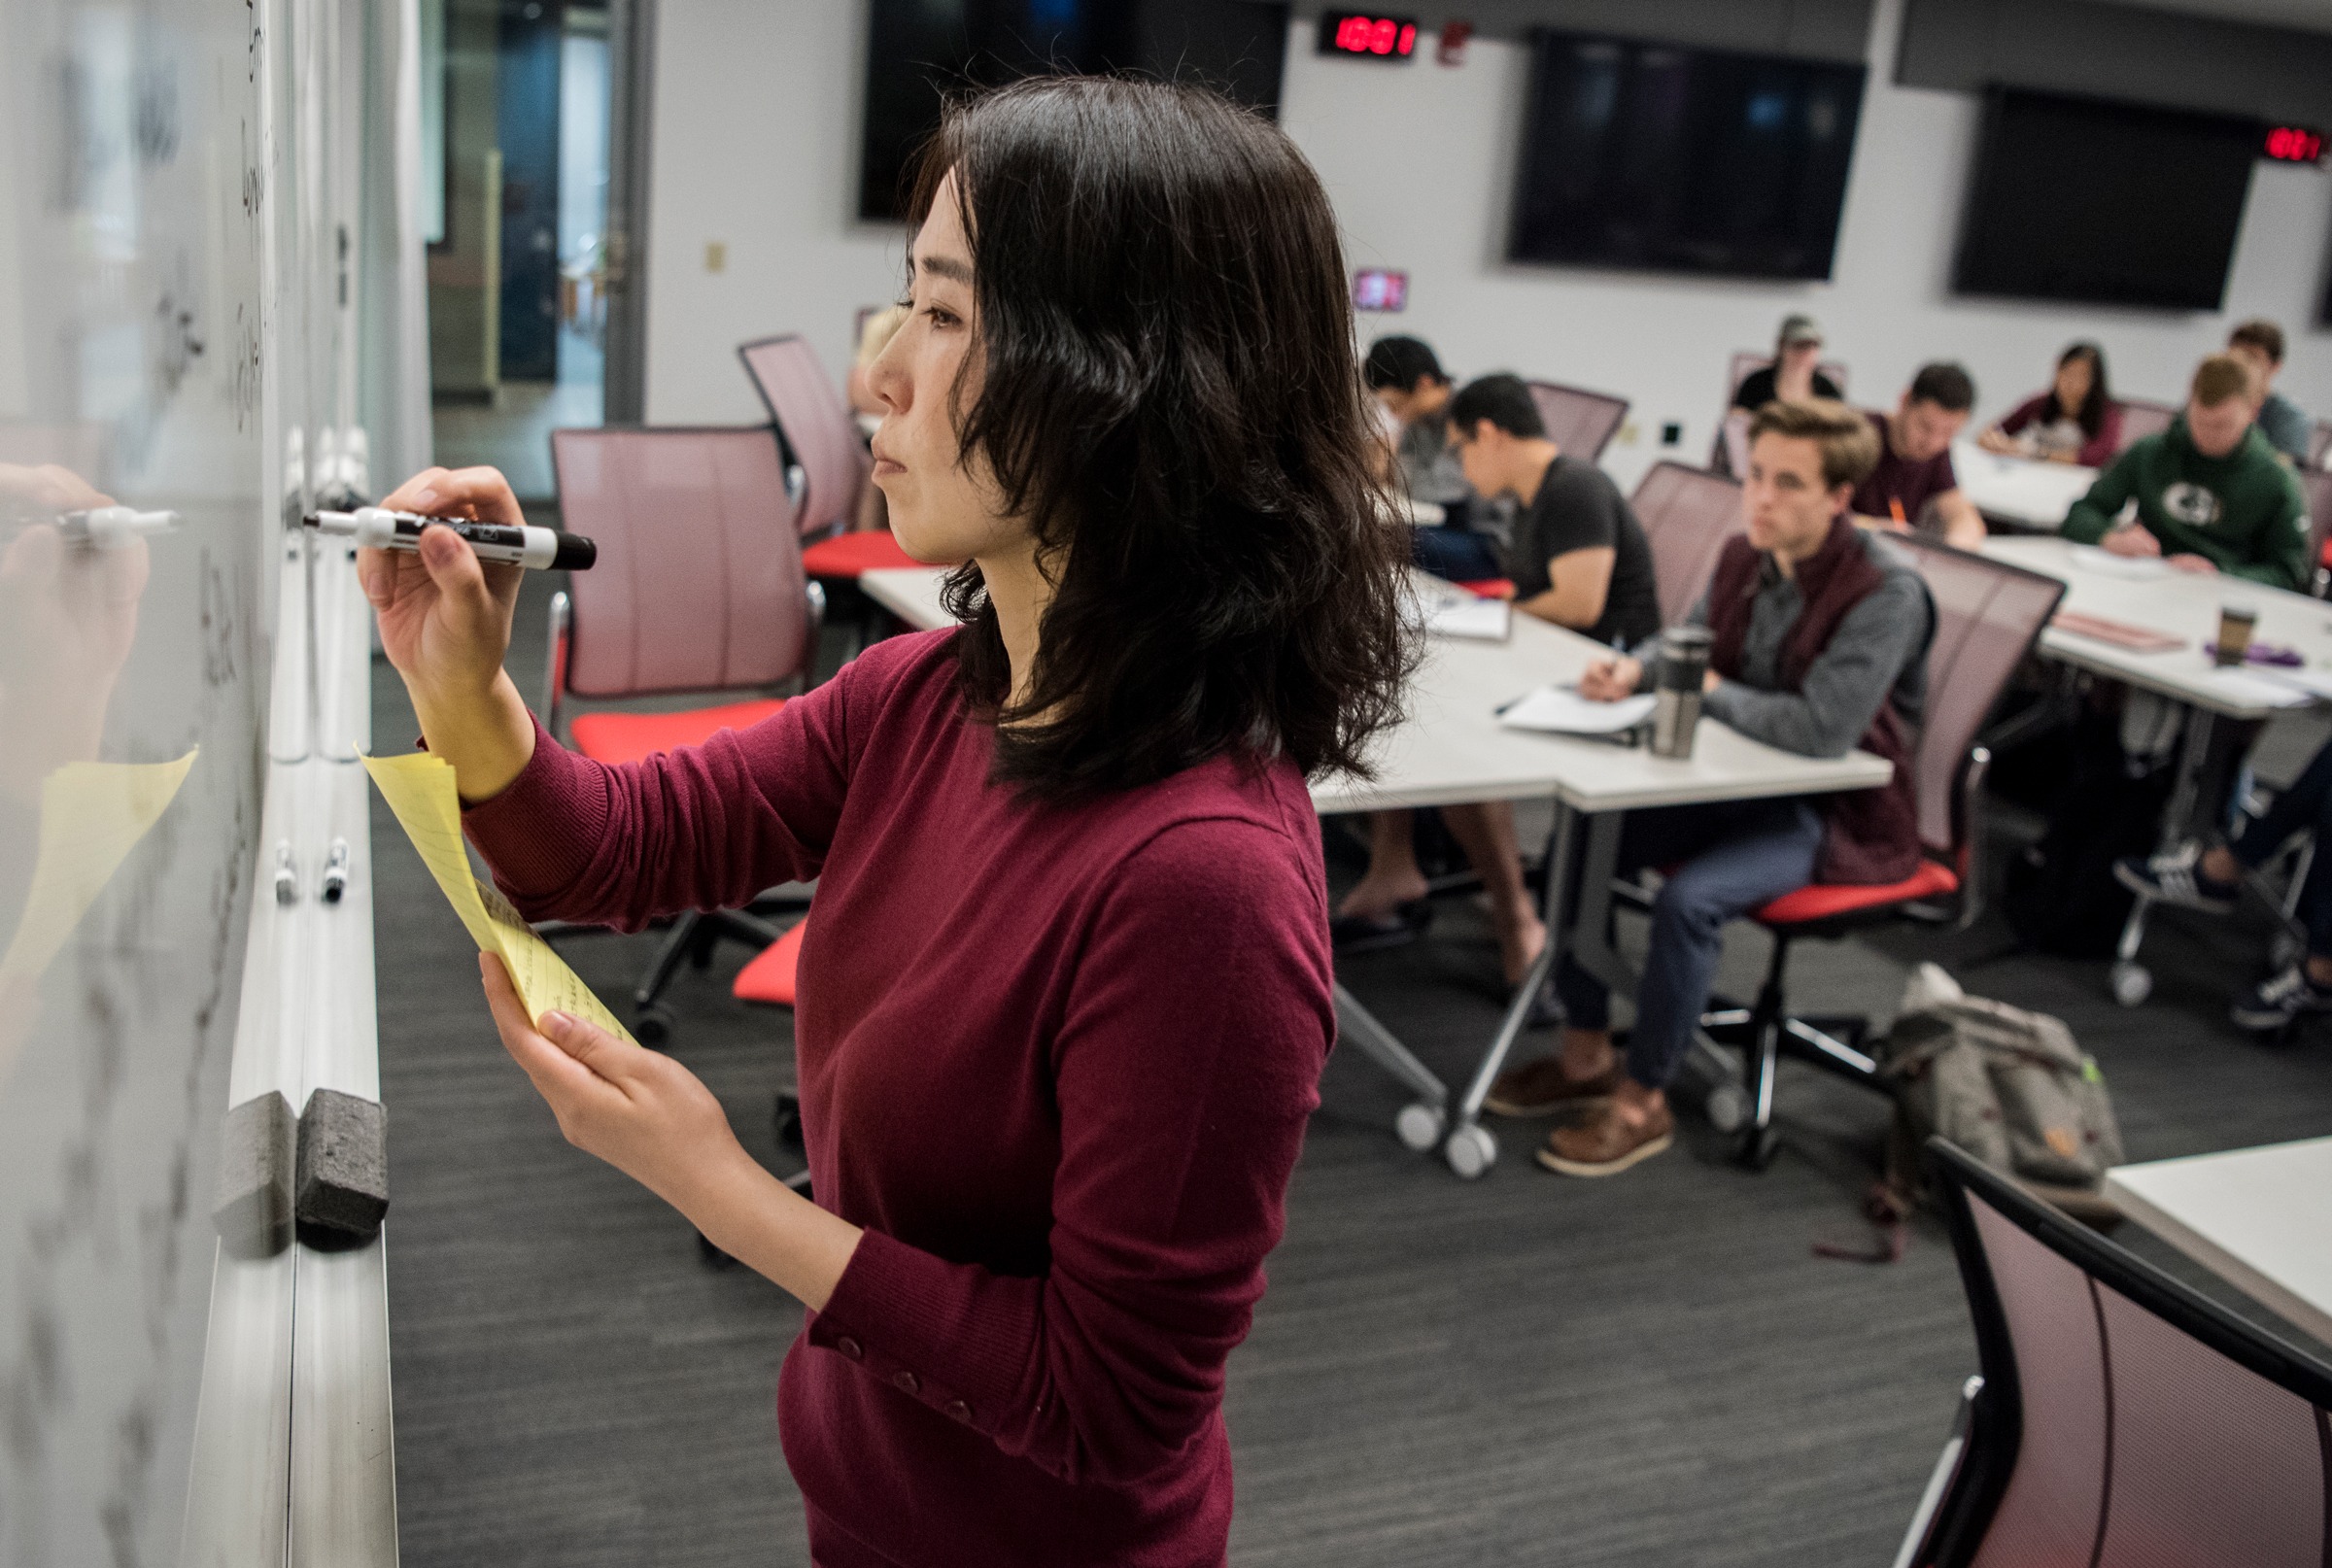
left=1488, top=401, right=1936, bottom=1176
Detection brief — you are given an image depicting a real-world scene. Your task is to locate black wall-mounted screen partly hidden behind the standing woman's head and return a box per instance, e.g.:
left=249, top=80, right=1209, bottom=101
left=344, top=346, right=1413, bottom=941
left=858, top=0, right=1287, bottom=222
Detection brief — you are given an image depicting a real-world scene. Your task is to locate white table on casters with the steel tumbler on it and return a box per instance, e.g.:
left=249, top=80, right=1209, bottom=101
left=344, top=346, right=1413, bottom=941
left=858, top=569, right=1894, bottom=1178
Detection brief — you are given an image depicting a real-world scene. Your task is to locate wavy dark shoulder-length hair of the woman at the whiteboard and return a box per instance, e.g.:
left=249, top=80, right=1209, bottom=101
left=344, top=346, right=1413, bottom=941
left=911, top=77, right=1416, bottom=801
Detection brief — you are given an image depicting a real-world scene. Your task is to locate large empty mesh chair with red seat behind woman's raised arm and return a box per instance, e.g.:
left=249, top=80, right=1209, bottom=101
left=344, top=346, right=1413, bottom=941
left=543, top=425, right=823, bottom=1045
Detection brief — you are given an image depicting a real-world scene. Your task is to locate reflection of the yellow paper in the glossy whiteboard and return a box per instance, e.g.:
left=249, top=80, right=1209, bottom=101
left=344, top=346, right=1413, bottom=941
left=0, top=747, right=200, bottom=994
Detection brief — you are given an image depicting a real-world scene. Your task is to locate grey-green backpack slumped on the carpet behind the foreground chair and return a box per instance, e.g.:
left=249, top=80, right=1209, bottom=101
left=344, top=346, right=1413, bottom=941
left=1814, top=964, right=2122, bottom=1262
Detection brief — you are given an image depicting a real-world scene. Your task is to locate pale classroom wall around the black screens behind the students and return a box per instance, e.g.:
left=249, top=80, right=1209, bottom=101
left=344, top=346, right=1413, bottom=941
left=648, top=0, right=2332, bottom=483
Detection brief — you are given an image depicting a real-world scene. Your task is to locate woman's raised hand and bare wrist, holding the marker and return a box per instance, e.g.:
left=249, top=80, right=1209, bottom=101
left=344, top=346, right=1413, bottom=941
left=357, top=469, right=534, bottom=802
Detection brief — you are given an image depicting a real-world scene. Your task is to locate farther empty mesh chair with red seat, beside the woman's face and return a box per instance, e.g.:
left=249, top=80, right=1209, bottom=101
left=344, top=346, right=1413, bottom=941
left=737, top=331, right=923, bottom=641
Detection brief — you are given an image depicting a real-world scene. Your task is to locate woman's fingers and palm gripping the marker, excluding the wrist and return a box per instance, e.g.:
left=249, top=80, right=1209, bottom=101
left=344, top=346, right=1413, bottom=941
left=357, top=469, right=525, bottom=700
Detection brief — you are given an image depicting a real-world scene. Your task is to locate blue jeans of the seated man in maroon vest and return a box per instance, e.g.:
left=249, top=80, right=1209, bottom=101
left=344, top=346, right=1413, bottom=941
left=1556, top=798, right=1821, bottom=1090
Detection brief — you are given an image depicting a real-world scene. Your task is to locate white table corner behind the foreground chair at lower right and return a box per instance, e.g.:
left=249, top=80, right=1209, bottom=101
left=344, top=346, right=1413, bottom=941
left=2106, top=1139, right=2332, bottom=1344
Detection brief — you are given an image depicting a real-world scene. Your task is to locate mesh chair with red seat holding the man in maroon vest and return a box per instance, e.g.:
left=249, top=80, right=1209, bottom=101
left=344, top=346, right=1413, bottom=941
left=1702, top=539, right=2064, bottom=1169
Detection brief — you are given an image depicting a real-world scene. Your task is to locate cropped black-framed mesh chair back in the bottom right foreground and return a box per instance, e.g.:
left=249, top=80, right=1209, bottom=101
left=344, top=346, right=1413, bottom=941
left=1896, top=1139, right=2332, bottom=1568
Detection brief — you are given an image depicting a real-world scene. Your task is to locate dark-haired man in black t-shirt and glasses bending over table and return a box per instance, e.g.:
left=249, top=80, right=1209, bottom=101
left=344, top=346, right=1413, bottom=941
left=1448, top=376, right=1661, bottom=649
